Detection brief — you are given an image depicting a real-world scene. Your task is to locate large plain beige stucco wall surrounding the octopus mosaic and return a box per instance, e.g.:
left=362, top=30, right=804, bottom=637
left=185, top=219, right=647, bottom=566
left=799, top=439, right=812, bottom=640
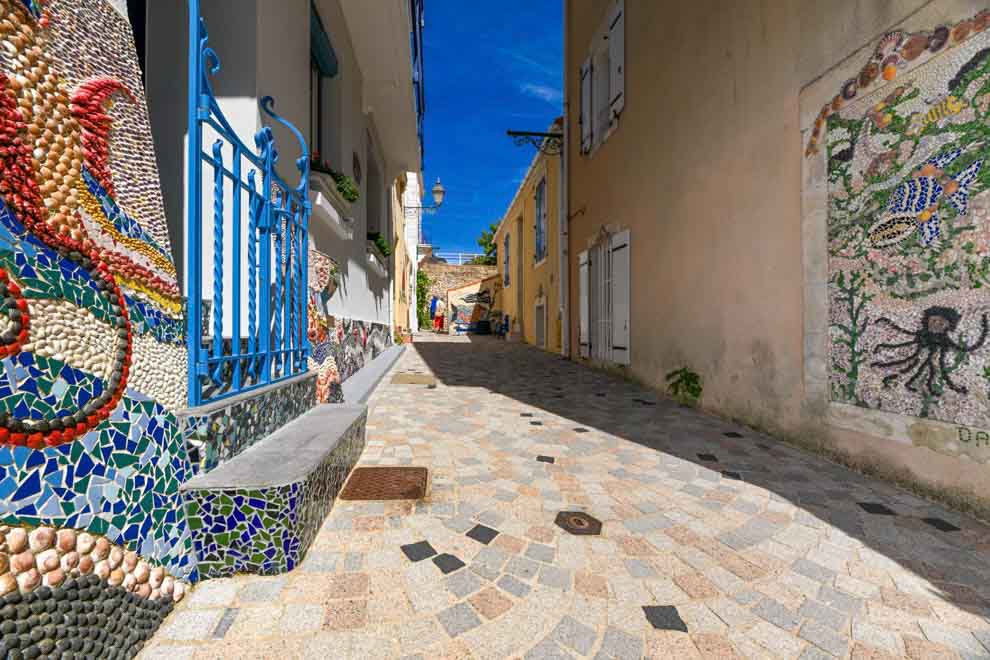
left=565, top=0, right=990, bottom=506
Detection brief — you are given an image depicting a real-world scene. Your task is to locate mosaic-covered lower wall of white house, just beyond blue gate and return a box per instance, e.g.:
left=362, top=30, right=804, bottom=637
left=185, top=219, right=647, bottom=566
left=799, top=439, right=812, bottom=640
left=308, top=249, right=392, bottom=403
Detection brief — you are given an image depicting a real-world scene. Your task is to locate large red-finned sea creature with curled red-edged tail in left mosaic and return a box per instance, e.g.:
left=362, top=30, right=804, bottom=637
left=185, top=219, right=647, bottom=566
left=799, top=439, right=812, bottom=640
left=0, top=0, right=180, bottom=448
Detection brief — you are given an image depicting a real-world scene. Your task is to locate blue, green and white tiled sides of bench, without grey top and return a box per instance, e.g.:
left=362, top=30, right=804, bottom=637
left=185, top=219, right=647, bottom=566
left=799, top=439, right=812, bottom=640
left=186, top=416, right=366, bottom=578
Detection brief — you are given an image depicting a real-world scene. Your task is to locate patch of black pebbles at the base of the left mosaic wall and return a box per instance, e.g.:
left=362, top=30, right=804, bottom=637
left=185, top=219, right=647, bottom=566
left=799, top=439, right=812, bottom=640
left=0, top=575, right=173, bottom=658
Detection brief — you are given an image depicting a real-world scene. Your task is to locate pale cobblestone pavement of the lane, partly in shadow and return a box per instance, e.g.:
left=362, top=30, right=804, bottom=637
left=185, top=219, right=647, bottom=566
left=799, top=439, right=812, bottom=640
left=143, top=338, right=990, bottom=660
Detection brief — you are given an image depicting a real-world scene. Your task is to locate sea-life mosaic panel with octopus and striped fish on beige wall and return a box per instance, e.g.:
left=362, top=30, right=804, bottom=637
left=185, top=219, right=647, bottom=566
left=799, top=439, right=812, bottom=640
left=824, top=10, right=990, bottom=438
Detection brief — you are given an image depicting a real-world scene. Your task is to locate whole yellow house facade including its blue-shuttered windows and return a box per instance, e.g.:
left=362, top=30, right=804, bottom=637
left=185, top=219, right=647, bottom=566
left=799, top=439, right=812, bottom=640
left=493, top=120, right=562, bottom=353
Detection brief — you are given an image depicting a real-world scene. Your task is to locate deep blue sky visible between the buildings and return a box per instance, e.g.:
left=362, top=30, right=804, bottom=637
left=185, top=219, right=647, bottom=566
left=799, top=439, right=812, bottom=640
left=414, top=0, right=564, bottom=252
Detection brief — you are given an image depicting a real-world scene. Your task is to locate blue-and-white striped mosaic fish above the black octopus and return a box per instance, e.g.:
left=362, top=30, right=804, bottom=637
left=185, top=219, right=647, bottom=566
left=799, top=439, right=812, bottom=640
left=867, top=149, right=983, bottom=248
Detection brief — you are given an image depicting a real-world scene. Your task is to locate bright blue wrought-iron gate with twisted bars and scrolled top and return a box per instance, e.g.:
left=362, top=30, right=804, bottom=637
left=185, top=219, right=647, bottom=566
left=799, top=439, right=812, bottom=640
left=186, top=0, right=311, bottom=406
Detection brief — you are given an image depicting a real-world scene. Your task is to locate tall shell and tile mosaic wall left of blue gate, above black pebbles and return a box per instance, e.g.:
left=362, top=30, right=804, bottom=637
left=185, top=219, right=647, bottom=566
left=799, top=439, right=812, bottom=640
left=0, top=0, right=196, bottom=608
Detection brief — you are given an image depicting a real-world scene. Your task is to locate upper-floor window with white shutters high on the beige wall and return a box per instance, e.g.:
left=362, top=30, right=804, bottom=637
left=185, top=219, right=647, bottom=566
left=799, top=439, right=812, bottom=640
left=579, top=0, right=626, bottom=154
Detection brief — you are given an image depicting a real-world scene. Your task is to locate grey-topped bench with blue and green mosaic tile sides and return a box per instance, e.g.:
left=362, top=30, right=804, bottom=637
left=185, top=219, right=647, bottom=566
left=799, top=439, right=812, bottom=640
left=180, top=404, right=367, bottom=578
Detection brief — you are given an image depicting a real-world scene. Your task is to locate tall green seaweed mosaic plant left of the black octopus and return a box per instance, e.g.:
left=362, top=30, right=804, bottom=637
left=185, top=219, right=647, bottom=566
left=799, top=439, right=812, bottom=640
left=832, top=271, right=873, bottom=405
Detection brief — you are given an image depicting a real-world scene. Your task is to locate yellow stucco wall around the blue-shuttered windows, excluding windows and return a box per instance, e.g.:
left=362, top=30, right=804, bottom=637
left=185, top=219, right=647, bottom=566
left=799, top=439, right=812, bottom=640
left=495, top=142, right=561, bottom=353
